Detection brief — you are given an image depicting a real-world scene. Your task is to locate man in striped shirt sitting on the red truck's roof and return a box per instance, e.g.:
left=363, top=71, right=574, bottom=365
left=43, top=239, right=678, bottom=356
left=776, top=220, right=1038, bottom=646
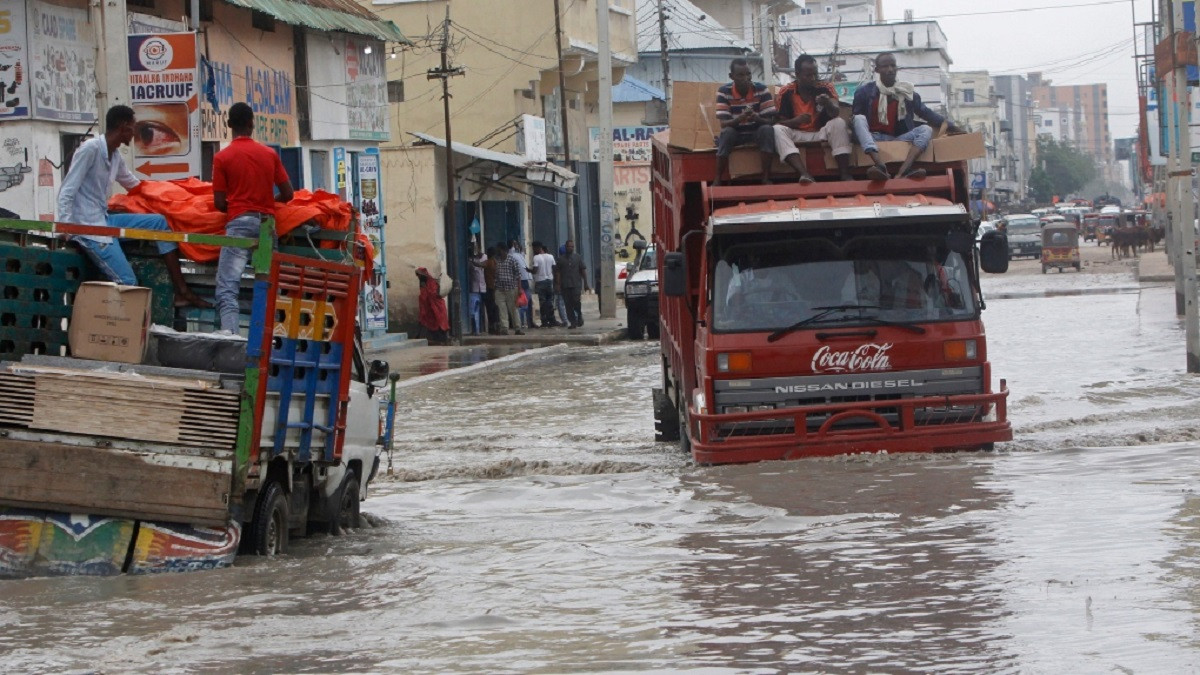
left=713, top=59, right=775, bottom=185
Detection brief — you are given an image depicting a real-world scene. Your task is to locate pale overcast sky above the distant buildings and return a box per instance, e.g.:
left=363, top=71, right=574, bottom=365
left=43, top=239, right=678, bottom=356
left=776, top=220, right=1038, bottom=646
left=883, top=0, right=1142, bottom=138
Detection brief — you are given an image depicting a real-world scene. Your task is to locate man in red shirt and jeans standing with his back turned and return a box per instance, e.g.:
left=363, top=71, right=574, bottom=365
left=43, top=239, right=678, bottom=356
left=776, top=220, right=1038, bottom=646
left=212, top=103, right=292, bottom=333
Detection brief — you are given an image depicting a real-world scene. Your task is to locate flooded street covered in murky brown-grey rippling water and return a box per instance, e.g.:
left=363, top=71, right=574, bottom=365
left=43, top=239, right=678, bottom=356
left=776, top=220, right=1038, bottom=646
left=0, top=274, right=1200, bottom=673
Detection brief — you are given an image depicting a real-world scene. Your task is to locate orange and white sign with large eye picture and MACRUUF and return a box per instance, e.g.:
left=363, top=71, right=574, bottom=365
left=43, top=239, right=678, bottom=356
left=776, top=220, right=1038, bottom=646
left=128, top=32, right=200, bottom=180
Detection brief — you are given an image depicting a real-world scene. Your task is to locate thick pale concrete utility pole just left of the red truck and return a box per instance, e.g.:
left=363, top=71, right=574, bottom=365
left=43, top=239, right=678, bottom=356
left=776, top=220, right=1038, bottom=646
left=596, top=0, right=617, bottom=318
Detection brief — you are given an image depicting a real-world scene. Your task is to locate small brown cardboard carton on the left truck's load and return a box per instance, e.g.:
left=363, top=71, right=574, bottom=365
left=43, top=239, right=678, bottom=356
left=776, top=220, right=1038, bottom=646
left=67, top=281, right=151, bottom=363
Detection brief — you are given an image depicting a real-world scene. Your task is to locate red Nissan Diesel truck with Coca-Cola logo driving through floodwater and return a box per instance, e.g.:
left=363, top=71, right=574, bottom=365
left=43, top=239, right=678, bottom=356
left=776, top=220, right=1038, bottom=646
left=653, top=137, right=1013, bottom=464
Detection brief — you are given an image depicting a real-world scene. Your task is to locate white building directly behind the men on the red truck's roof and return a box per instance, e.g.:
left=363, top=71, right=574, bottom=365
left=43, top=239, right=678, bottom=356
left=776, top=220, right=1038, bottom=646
left=781, top=22, right=953, bottom=112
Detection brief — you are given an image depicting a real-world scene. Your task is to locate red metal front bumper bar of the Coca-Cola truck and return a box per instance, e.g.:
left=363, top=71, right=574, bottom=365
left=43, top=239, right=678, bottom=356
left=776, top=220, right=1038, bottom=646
left=688, top=380, right=1013, bottom=464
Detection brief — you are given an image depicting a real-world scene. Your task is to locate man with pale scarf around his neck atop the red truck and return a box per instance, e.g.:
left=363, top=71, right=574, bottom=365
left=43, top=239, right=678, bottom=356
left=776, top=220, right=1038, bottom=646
left=854, top=52, right=961, bottom=180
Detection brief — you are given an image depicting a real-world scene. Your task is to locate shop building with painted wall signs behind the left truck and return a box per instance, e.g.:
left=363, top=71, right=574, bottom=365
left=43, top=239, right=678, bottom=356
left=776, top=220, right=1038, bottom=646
left=0, top=0, right=407, bottom=330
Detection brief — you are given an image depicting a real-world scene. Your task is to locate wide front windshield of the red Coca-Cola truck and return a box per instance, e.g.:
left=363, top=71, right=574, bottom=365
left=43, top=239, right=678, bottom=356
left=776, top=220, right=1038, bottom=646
left=713, top=237, right=978, bottom=333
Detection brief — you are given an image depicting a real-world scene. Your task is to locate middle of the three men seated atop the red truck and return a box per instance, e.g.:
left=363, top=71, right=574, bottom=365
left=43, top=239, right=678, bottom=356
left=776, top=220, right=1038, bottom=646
left=775, top=54, right=851, bottom=185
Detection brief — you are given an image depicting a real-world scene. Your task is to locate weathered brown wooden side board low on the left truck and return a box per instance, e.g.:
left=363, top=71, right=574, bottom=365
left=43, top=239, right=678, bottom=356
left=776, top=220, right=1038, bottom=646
left=0, top=438, right=232, bottom=526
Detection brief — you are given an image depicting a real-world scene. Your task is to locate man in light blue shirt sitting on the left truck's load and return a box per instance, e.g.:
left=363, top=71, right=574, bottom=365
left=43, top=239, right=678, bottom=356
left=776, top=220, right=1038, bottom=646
left=59, top=106, right=212, bottom=307
